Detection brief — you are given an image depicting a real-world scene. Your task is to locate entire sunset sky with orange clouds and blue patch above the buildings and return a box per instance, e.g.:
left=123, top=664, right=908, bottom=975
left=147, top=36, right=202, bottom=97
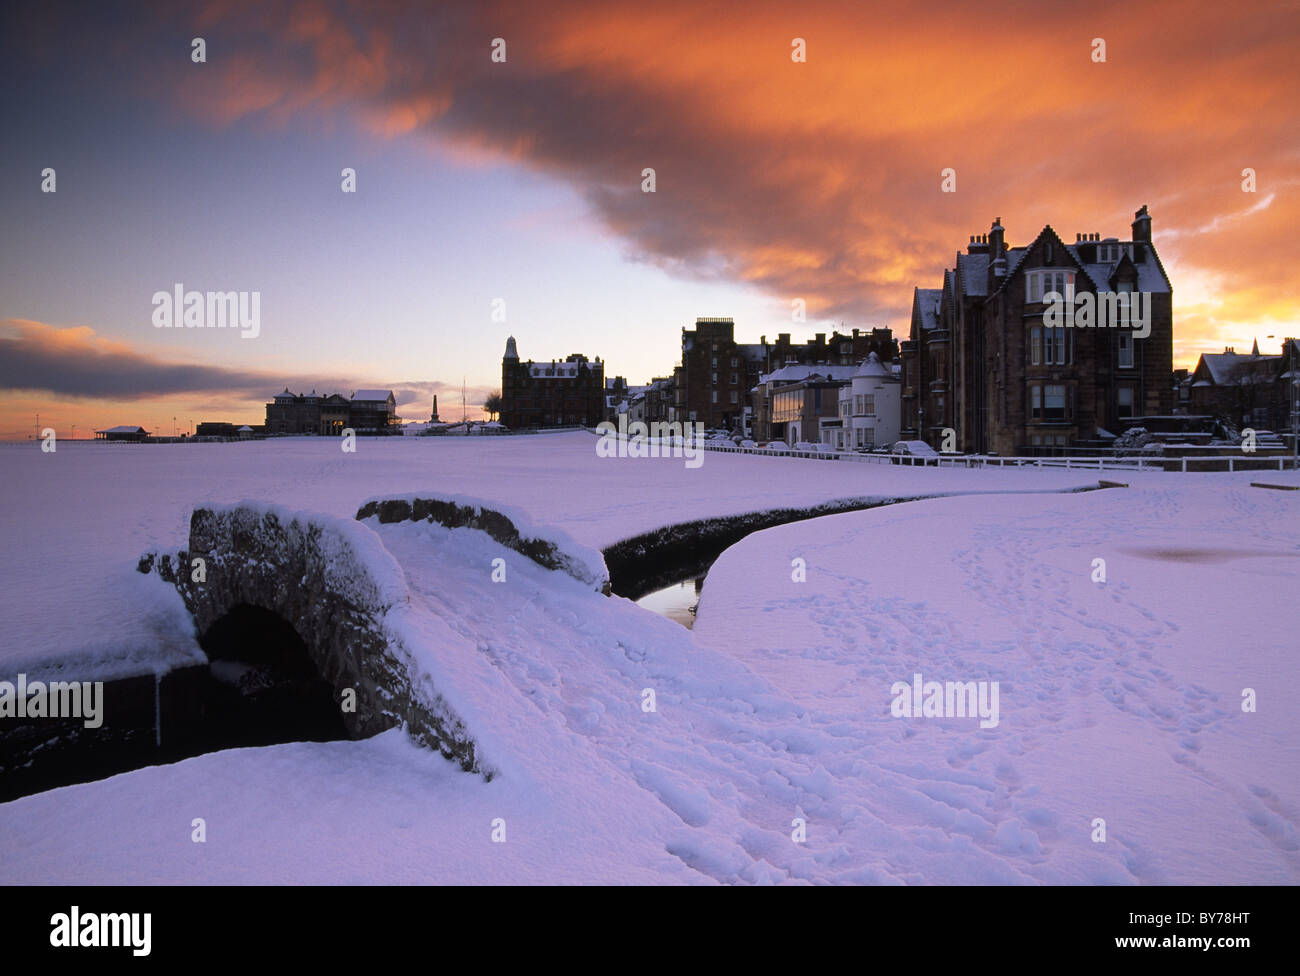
left=0, top=0, right=1300, bottom=439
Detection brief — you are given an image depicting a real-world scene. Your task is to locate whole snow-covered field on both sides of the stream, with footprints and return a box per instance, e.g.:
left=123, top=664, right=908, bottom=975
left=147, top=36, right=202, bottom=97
left=0, top=434, right=1300, bottom=884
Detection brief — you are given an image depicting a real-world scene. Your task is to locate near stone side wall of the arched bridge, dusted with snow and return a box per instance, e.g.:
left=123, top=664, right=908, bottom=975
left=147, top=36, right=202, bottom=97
left=139, top=502, right=493, bottom=778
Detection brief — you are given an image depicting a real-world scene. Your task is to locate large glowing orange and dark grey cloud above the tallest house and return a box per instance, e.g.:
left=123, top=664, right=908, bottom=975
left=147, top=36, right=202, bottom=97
left=10, top=0, right=1300, bottom=355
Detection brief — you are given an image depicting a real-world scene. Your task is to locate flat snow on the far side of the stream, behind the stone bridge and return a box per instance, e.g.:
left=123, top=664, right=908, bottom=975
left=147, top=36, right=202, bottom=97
left=0, top=431, right=1097, bottom=677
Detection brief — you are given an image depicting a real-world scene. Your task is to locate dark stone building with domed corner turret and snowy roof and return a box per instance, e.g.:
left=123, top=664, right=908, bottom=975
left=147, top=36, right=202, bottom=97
left=501, top=335, right=606, bottom=430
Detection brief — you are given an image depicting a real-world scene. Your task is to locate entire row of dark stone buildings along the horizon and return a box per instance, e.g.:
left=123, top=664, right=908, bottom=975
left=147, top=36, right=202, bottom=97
left=172, top=207, right=1300, bottom=455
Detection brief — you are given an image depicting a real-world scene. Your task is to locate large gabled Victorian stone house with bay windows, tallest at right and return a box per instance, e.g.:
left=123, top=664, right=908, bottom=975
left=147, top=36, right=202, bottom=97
left=900, top=207, right=1174, bottom=455
